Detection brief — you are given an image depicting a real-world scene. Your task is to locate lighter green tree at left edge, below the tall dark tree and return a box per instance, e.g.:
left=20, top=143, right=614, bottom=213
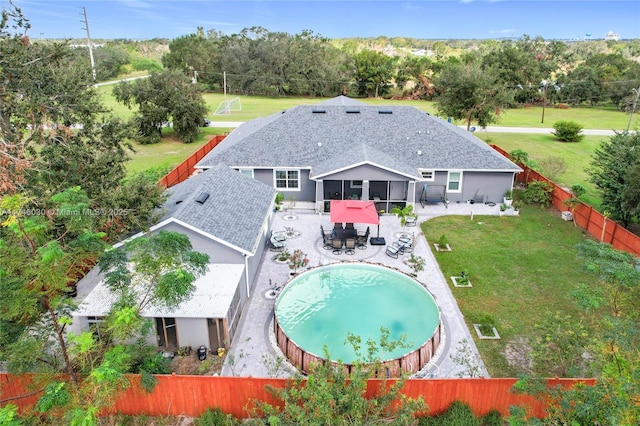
left=0, top=187, right=104, bottom=387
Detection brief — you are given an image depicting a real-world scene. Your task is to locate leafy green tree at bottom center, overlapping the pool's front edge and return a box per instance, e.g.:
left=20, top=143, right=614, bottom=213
left=256, top=328, right=427, bottom=425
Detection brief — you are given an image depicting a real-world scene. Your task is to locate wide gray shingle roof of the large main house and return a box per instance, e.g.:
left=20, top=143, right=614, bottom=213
left=198, top=96, right=520, bottom=175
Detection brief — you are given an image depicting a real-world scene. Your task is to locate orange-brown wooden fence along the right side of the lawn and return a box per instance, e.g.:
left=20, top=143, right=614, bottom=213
left=491, top=145, right=640, bottom=256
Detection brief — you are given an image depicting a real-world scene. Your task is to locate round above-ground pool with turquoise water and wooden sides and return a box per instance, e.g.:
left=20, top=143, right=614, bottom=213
left=274, top=263, right=442, bottom=376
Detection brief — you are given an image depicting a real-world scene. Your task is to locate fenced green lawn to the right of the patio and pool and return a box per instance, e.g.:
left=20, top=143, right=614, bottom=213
left=422, top=206, right=594, bottom=377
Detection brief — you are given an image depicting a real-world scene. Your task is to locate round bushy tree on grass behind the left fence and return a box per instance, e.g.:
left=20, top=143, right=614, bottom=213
left=113, top=70, right=207, bottom=143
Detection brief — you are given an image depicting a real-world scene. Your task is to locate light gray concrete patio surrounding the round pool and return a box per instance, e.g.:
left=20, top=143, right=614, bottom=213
left=222, top=203, right=500, bottom=378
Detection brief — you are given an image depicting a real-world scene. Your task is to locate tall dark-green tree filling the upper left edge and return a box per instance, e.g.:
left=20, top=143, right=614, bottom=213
left=0, top=4, right=162, bottom=241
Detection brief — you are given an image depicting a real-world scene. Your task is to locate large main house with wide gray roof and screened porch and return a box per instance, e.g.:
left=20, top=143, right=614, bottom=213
left=197, top=96, right=522, bottom=212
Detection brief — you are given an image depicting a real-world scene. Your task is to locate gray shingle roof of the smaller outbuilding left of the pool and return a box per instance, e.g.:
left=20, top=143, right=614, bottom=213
left=161, top=165, right=276, bottom=253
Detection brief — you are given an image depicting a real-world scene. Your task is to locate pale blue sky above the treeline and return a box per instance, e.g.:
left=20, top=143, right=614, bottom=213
left=10, top=0, right=640, bottom=40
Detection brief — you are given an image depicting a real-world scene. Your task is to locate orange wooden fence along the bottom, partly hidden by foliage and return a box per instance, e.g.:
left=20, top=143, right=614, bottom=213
left=0, top=374, right=595, bottom=418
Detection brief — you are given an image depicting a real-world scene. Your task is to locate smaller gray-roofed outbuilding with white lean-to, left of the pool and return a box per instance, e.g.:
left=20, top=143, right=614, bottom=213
left=74, top=165, right=276, bottom=351
